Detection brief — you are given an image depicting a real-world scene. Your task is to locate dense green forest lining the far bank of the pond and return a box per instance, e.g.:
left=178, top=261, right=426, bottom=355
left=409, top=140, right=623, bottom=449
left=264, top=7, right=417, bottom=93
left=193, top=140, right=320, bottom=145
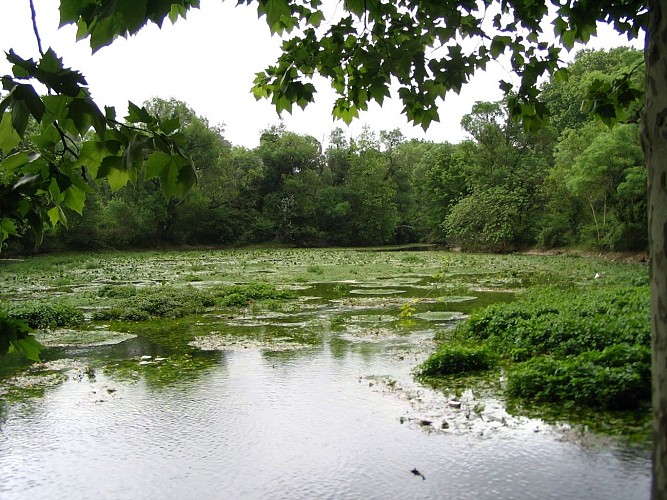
left=8, top=47, right=647, bottom=253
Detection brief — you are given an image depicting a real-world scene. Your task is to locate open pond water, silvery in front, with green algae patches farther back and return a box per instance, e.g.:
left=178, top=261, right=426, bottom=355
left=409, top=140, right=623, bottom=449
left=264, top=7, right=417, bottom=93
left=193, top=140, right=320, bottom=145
left=0, top=250, right=650, bottom=499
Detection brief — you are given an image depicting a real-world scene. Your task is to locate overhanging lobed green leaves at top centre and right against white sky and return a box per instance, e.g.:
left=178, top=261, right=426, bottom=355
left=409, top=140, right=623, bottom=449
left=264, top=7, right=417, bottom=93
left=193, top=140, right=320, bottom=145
left=253, top=0, right=648, bottom=131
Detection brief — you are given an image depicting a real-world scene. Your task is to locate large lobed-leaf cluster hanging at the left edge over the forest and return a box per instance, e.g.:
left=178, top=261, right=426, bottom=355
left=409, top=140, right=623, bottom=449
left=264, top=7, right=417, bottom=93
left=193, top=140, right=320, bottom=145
left=0, top=43, right=196, bottom=252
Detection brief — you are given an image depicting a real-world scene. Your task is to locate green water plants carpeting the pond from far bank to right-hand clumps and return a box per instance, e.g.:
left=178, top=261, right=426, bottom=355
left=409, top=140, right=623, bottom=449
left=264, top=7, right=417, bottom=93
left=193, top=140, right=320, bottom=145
left=0, top=248, right=648, bottom=434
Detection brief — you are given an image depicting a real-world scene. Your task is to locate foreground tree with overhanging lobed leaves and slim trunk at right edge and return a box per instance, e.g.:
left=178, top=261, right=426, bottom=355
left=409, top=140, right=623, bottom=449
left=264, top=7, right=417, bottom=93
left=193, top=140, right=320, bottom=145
left=5, top=0, right=667, bottom=498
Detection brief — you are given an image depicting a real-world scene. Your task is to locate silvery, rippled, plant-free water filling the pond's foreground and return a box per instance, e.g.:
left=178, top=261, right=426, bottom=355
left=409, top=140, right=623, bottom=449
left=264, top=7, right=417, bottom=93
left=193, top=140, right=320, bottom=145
left=0, top=338, right=650, bottom=500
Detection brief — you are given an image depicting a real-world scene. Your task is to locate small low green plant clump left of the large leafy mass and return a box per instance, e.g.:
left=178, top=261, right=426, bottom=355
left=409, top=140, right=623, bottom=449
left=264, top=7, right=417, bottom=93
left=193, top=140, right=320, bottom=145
left=417, top=344, right=497, bottom=377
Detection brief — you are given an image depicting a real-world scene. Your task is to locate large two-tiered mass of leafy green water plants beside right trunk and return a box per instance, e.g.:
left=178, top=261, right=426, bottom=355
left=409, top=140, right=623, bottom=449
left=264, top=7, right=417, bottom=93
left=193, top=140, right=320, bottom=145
left=456, top=287, right=651, bottom=409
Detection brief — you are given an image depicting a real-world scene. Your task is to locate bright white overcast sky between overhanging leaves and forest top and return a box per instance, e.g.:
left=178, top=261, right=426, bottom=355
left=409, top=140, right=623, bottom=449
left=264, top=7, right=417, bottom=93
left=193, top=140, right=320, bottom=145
left=0, top=0, right=640, bottom=148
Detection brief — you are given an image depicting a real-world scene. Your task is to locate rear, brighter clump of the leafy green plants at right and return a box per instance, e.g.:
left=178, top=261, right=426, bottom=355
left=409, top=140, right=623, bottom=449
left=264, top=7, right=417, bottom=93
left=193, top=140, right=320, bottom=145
left=456, top=287, right=651, bottom=361
